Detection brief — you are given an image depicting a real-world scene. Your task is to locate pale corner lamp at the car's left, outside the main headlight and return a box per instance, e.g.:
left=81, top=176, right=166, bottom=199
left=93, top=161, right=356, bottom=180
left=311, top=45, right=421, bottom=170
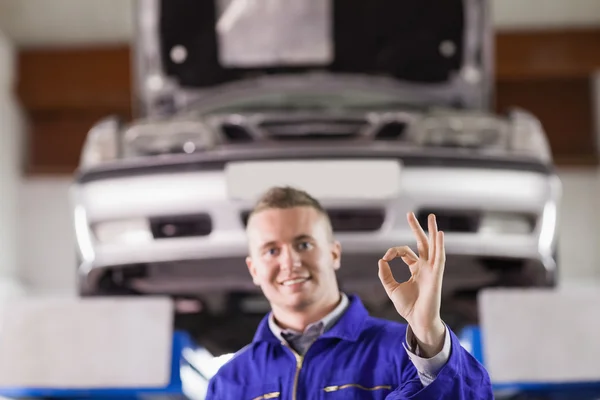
left=80, top=116, right=121, bottom=168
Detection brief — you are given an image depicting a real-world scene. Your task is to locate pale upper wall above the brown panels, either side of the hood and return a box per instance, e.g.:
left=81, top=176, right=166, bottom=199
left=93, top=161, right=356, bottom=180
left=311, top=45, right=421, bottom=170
left=0, top=0, right=600, bottom=46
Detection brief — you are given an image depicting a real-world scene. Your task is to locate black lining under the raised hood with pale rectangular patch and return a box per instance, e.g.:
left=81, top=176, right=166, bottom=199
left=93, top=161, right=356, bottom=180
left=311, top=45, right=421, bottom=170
left=158, top=0, right=466, bottom=87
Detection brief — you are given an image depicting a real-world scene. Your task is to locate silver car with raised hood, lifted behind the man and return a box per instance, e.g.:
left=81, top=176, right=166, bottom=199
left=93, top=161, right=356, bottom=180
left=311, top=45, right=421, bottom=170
left=71, top=0, right=561, bottom=347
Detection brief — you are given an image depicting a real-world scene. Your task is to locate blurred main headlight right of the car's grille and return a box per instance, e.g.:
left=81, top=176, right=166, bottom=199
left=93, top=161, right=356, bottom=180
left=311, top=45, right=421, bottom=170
left=413, top=111, right=509, bottom=150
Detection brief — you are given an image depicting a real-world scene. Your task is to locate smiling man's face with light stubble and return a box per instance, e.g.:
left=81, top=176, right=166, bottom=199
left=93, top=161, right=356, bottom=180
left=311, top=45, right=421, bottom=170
left=246, top=207, right=341, bottom=311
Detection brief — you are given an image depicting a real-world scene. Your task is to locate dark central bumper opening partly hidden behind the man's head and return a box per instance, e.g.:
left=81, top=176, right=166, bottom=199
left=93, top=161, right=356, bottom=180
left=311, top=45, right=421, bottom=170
left=241, top=208, right=385, bottom=232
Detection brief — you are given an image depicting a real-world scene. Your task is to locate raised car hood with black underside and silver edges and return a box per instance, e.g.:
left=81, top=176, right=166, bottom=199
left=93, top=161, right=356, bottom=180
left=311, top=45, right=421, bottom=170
left=134, top=0, right=492, bottom=115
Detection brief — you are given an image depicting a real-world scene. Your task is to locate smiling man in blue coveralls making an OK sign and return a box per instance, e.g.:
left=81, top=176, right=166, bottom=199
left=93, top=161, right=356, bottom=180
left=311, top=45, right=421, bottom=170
left=207, top=187, right=494, bottom=400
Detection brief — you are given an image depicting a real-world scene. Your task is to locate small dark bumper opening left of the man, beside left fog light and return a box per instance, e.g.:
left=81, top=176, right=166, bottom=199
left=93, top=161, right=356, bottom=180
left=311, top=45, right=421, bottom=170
left=150, top=214, right=213, bottom=239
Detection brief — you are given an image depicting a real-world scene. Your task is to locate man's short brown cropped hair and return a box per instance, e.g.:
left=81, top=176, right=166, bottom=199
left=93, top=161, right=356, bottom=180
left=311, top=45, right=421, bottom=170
left=248, top=186, right=332, bottom=233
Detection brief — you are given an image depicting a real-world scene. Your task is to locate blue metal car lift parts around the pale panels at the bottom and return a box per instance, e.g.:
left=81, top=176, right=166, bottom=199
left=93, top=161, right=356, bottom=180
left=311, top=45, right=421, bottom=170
left=0, top=326, right=600, bottom=400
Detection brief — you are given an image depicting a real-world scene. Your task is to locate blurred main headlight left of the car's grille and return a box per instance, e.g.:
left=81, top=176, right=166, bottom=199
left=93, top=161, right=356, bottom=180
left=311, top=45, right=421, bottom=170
left=123, top=119, right=216, bottom=156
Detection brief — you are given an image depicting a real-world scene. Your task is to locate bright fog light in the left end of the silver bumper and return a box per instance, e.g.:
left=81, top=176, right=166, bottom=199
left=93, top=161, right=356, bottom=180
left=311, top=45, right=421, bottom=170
left=93, top=218, right=153, bottom=244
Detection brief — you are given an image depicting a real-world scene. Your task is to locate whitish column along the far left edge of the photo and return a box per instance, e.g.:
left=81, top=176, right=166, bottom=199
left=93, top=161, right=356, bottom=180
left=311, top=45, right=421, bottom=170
left=0, top=31, right=24, bottom=300
